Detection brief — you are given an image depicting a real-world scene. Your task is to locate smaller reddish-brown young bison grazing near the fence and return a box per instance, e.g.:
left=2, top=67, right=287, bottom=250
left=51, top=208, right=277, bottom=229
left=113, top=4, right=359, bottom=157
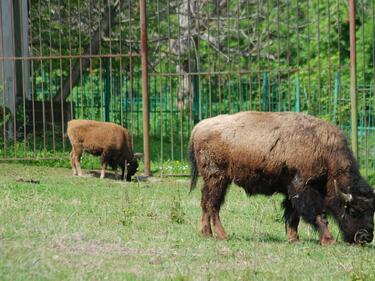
left=67, top=120, right=138, bottom=181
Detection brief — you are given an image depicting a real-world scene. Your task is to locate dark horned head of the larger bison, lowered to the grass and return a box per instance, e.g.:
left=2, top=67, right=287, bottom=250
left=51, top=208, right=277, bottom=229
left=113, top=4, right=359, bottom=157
left=334, top=178, right=375, bottom=244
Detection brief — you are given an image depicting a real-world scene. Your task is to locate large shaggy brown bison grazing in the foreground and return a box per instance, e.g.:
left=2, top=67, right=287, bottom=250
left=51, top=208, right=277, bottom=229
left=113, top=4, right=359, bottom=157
left=189, top=112, right=375, bottom=245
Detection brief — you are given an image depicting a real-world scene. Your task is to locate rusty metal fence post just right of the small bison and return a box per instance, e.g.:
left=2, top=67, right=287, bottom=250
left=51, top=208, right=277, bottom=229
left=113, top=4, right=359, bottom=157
left=139, top=0, right=150, bottom=176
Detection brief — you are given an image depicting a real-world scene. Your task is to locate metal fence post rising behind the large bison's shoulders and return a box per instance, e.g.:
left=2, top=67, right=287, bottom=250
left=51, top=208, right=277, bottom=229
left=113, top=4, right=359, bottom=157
left=349, top=0, right=358, bottom=159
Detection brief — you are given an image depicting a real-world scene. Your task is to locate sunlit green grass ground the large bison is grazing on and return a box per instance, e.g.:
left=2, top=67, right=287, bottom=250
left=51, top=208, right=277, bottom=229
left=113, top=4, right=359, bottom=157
left=0, top=163, right=375, bottom=280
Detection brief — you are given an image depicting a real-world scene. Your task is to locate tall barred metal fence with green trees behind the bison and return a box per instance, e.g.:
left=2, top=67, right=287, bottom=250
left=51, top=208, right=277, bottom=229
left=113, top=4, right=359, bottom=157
left=0, top=0, right=375, bottom=173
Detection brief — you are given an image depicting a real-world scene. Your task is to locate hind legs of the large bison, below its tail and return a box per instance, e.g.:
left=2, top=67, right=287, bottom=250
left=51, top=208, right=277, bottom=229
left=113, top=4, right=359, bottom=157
left=201, top=176, right=230, bottom=240
